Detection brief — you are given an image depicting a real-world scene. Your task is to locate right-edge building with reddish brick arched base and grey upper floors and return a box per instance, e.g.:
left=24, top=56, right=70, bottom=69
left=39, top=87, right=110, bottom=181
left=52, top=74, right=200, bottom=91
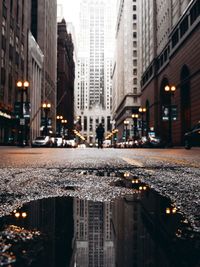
left=139, top=0, right=200, bottom=145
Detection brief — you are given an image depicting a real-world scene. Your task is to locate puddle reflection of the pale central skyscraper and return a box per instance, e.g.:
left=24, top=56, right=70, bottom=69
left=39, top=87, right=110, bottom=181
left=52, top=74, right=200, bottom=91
left=71, top=199, right=115, bottom=267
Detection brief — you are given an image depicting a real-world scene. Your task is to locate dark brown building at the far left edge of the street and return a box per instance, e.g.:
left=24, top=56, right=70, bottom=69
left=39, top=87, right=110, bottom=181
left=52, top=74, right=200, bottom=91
left=0, top=0, right=30, bottom=144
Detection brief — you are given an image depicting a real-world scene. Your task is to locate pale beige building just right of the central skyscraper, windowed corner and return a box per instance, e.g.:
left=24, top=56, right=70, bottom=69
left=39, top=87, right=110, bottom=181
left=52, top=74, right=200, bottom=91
left=112, top=0, right=140, bottom=141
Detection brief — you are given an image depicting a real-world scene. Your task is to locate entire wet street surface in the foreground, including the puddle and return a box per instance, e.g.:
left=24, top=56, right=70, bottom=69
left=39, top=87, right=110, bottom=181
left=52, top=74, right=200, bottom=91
left=0, top=148, right=200, bottom=267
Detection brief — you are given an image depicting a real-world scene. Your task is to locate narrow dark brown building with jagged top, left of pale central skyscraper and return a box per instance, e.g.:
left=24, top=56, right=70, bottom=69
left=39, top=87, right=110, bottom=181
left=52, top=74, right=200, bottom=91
left=56, top=19, right=75, bottom=138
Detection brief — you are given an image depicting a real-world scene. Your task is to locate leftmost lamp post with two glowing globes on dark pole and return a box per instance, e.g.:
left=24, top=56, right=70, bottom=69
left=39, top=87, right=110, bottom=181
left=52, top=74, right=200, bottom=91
left=17, top=81, right=29, bottom=146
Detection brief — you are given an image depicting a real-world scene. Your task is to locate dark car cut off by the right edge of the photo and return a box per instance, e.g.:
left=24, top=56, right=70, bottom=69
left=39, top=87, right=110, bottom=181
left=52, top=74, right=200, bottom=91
left=184, top=121, right=200, bottom=149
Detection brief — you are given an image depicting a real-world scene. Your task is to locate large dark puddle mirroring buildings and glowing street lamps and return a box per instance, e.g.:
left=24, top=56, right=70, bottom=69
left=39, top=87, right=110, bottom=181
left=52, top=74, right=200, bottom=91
left=0, top=173, right=199, bottom=267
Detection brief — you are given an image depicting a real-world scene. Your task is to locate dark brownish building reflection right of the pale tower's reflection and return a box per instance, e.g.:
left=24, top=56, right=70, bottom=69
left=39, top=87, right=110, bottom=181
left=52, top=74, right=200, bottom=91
left=112, top=193, right=142, bottom=267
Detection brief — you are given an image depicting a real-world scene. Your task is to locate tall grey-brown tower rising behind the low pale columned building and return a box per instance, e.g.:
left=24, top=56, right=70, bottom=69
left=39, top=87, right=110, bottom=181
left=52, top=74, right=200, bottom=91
left=31, top=0, right=57, bottom=133
